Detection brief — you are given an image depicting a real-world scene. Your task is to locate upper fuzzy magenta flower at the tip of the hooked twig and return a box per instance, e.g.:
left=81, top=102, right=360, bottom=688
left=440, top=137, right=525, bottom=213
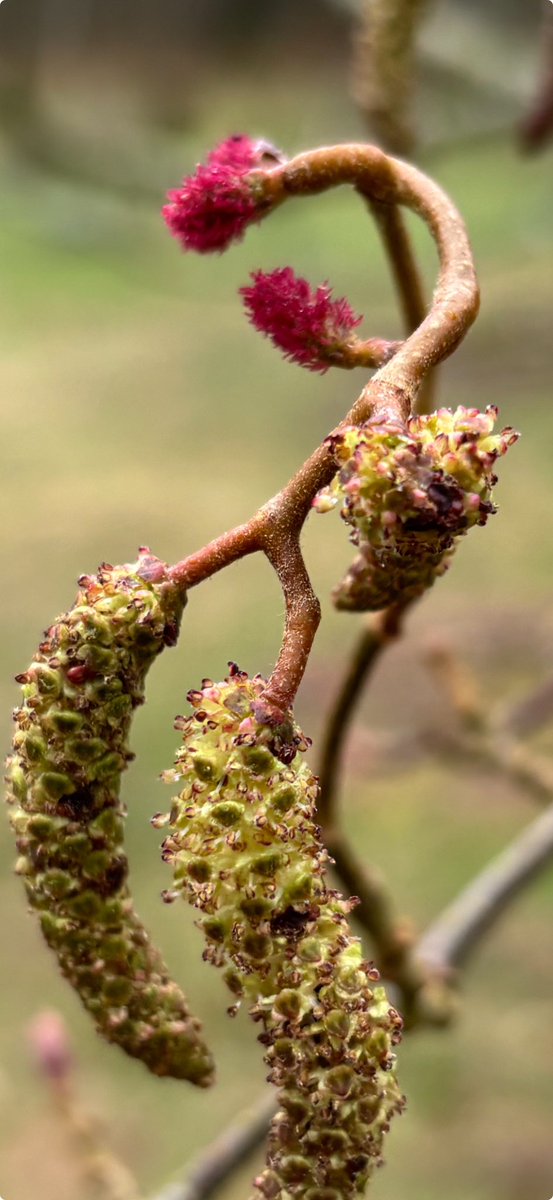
left=163, top=134, right=264, bottom=254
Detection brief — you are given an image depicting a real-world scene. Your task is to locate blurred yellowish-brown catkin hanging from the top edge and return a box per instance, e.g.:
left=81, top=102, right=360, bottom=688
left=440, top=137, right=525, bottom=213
left=353, top=0, right=428, bottom=155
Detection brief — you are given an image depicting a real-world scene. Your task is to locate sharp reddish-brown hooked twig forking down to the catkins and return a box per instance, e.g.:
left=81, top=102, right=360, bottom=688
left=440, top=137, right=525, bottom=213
left=170, top=144, right=479, bottom=721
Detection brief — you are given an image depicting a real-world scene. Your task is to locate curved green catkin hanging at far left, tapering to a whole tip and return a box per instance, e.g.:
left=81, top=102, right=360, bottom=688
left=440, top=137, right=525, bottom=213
left=7, top=548, right=212, bottom=1086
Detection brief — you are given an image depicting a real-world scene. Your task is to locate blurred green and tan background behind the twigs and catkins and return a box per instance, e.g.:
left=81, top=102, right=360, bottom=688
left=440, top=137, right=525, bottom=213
left=0, top=0, right=553, bottom=1200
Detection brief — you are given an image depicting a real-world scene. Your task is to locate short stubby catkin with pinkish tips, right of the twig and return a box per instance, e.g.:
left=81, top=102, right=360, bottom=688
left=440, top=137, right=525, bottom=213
left=315, top=406, right=518, bottom=612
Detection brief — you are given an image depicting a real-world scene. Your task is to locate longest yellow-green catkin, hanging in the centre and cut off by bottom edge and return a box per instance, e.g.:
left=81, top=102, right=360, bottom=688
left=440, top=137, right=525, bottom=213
left=159, top=666, right=403, bottom=1200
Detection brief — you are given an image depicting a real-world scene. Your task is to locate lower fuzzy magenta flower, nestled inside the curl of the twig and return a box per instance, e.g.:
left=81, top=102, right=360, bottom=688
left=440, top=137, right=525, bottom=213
left=240, top=266, right=362, bottom=372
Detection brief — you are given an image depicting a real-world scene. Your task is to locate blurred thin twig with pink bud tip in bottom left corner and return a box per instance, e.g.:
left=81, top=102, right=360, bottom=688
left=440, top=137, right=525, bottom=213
left=29, top=1012, right=140, bottom=1200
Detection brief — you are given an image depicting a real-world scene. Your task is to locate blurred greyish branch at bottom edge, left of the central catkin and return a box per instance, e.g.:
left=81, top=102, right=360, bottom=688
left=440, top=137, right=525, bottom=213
left=148, top=1094, right=276, bottom=1200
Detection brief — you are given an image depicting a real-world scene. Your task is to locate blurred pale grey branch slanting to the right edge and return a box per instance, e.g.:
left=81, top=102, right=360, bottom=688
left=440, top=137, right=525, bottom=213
left=416, top=805, right=553, bottom=971
